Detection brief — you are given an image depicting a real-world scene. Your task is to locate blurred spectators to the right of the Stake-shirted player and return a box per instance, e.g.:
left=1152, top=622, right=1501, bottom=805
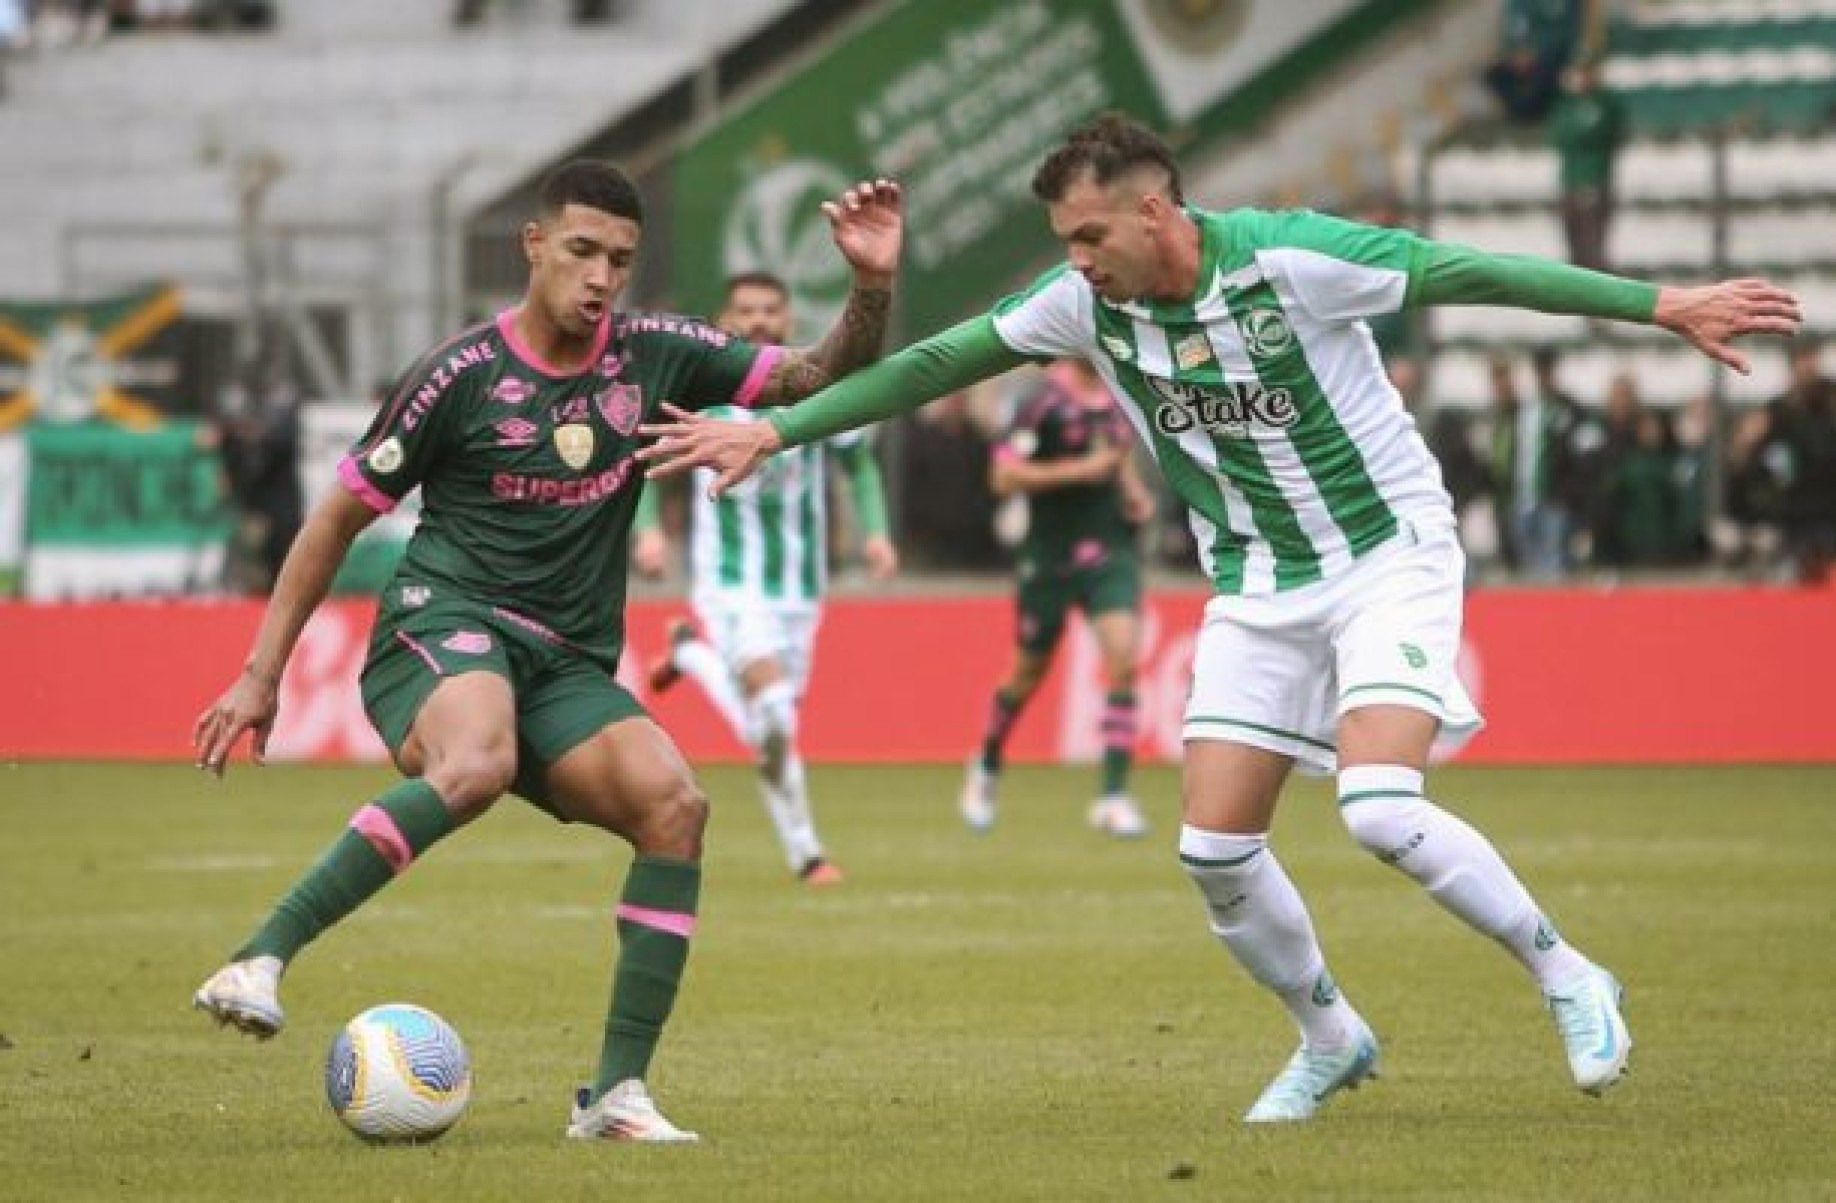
left=1423, top=342, right=1836, bottom=580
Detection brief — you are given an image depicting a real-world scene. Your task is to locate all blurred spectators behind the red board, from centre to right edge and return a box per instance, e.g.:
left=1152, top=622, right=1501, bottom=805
left=883, top=340, right=1836, bottom=582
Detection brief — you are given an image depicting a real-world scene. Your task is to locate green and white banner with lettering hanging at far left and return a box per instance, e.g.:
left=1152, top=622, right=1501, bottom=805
left=20, top=421, right=233, bottom=599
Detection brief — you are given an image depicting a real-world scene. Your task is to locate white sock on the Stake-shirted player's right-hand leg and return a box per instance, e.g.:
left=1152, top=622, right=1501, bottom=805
left=1338, top=764, right=1588, bottom=990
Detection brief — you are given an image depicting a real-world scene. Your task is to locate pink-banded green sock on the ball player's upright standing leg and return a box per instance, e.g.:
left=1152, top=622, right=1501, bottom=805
left=593, top=854, right=701, bottom=1098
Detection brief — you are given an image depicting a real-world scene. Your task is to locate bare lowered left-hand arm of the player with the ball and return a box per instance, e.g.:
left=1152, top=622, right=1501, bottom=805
left=191, top=489, right=376, bottom=777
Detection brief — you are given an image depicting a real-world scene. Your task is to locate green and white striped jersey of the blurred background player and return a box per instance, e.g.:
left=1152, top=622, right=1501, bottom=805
left=689, top=406, right=865, bottom=606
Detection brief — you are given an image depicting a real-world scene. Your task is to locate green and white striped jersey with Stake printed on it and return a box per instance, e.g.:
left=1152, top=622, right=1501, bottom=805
left=991, top=209, right=1454, bottom=595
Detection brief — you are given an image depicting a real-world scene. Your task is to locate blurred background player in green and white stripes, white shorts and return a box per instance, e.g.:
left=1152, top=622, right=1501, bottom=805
left=632, top=272, right=898, bottom=885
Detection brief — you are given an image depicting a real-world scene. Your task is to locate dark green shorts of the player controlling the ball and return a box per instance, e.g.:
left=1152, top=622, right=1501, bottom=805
left=358, top=602, right=646, bottom=814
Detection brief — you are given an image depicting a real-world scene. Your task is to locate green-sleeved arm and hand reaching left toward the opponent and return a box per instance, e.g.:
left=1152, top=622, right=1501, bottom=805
left=637, top=318, right=1026, bottom=498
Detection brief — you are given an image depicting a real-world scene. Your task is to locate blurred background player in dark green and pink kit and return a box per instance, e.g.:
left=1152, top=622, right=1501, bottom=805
left=958, top=360, right=1153, bottom=836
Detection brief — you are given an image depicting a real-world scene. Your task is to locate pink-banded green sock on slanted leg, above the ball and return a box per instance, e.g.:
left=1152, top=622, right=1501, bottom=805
left=233, top=777, right=457, bottom=962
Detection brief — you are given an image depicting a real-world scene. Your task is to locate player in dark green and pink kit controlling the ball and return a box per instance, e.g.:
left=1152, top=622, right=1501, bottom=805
left=193, top=162, right=903, bottom=1142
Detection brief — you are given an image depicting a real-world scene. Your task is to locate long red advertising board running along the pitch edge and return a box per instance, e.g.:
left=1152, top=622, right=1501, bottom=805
left=0, top=588, right=1836, bottom=764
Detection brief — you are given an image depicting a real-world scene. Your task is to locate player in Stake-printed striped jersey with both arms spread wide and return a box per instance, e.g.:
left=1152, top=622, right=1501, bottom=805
left=641, top=114, right=1801, bottom=1122
